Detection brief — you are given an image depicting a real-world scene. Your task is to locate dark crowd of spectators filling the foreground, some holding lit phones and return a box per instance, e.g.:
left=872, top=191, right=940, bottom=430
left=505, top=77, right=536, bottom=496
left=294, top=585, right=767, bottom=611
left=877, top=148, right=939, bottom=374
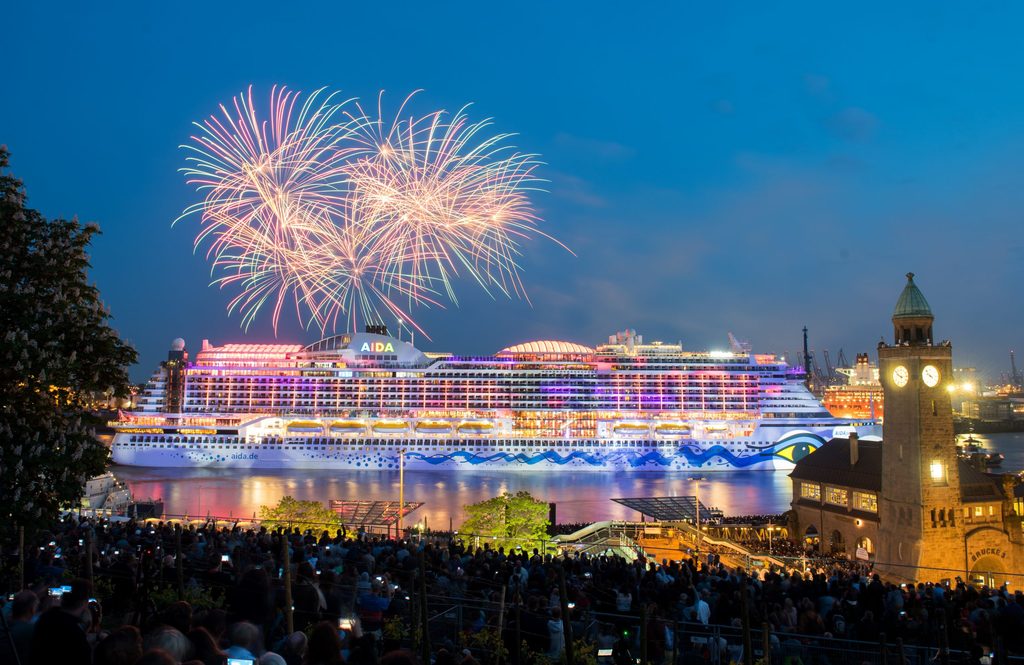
left=0, top=518, right=1024, bottom=665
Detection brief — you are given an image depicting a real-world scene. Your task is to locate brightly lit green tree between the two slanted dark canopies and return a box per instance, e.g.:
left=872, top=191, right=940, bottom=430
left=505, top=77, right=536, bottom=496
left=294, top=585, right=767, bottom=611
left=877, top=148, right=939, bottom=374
left=462, top=492, right=548, bottom=550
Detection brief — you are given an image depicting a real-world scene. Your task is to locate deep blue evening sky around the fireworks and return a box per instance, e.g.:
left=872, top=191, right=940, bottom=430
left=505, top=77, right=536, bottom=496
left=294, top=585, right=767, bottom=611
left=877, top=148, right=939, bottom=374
left=0, top=2, right=1024, bottom=379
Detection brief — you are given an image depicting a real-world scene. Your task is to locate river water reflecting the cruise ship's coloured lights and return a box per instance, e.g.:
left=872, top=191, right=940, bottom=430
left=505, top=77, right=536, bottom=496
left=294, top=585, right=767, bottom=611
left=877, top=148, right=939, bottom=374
left=114, top=432, right=1024, bottom=529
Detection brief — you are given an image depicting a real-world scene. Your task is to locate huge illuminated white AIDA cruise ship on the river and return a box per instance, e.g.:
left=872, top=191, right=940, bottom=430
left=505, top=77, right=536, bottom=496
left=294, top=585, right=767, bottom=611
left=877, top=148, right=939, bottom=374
left=111, top=327, right=880, bottom=471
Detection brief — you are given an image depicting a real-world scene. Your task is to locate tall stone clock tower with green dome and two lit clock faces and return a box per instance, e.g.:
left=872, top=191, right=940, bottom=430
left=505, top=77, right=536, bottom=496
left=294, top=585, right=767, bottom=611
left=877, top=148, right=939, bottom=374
left=877, top=273, right=965, bottom=580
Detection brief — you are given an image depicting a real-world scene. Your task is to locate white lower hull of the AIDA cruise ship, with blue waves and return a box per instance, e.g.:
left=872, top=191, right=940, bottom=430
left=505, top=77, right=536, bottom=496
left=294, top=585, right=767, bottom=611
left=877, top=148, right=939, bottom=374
left=112, top=426, right=873, bottom=471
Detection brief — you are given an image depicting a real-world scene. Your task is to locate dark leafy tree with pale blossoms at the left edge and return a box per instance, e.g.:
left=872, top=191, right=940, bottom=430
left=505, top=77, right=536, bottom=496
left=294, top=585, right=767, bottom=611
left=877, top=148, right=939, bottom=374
left=0, top=147, right=136, bottom=542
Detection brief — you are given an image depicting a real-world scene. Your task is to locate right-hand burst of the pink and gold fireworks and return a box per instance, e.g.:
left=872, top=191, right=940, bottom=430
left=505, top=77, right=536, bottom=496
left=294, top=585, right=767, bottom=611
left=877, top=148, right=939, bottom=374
left=346, top=93, right=552, bottom=301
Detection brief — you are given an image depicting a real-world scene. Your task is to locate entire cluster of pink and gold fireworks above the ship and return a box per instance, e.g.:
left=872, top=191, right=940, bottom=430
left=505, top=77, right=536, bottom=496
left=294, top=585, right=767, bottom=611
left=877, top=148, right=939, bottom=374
left=179, top=87, right=557, bottom=332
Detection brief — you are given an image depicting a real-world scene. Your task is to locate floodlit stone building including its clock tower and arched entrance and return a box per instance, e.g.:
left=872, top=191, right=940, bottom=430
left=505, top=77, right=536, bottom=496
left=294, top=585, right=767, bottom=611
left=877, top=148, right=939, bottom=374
left=790, top=274, right=1024, bottom=586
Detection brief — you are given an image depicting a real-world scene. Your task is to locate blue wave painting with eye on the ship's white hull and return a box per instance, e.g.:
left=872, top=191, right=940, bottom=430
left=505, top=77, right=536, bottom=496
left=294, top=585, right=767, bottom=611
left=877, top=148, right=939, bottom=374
left=407, top=431, right=825, bottom=468
